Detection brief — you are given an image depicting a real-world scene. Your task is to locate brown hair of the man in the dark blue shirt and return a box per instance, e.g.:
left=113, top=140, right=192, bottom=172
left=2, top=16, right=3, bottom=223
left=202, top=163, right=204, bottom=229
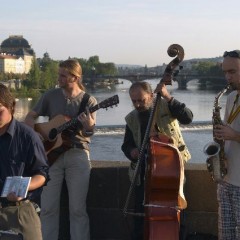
left=0, top=83, right=16, bottom=115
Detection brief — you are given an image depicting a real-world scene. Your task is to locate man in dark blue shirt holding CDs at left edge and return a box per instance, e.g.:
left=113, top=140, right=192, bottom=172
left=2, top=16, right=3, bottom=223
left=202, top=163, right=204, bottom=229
left=0, top=84, right=48, bottom=240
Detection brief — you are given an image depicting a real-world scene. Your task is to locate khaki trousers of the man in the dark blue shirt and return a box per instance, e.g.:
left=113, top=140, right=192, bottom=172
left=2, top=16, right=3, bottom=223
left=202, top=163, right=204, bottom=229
left=0, top=200, right=42, bottom=240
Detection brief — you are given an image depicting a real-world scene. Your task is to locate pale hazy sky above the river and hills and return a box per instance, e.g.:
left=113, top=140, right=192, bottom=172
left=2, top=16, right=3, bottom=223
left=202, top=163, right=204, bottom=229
left=0, top=0, right=240, bottom=67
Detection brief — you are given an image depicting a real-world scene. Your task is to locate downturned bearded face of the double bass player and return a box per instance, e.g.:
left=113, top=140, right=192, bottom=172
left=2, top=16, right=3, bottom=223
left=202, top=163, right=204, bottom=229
left=130, top=87, right=153, bottom=112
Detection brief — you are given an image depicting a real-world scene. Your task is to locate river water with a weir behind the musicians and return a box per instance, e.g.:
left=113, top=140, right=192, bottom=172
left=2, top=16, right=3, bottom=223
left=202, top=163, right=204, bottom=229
left=15, top=79, right=227, bottom=163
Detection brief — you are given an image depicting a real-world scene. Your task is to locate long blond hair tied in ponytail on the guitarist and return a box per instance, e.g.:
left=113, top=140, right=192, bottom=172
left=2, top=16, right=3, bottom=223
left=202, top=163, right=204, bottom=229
left=59, top=59, right=85, bottom=91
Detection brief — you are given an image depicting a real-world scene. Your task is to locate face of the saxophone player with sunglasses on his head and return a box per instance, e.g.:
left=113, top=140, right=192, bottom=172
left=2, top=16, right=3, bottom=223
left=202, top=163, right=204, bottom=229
left=222, top=56, right=240, bottom=91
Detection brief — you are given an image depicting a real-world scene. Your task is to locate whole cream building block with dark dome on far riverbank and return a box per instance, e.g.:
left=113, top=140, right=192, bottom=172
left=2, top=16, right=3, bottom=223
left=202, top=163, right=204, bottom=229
left=0, top=35, right=35, bottom=74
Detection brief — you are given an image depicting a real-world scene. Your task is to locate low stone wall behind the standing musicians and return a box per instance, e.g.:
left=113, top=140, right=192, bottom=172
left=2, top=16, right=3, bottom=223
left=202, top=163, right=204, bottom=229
left=59, top=161, right=217, bottom=240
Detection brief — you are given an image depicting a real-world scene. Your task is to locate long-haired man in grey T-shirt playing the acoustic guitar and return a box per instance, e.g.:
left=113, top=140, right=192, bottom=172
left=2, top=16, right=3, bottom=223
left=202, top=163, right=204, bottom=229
left=25, top=59, right=97, bottom=240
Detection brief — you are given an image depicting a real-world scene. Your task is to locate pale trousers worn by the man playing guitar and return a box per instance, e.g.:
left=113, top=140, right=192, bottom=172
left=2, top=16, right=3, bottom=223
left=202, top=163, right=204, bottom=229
left=40, top=148, right=91, bottom=240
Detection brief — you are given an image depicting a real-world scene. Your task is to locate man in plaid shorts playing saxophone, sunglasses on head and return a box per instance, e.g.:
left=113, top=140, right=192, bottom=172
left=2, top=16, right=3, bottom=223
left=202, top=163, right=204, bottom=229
left=214, top=50, right=240, bottom=240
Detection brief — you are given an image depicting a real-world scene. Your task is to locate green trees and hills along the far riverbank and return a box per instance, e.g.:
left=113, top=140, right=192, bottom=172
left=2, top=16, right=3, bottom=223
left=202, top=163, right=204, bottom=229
left=0, top=53, right=224, bottom=96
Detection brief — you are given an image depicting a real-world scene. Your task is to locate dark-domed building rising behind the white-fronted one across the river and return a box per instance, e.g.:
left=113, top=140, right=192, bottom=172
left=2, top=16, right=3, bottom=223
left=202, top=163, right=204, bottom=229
left=0, top=35, right=35, bottom=73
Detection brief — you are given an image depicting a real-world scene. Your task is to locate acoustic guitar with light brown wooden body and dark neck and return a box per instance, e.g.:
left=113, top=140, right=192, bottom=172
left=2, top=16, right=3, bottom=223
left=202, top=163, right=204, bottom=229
left=34, top=95, right=119, bottom=165
